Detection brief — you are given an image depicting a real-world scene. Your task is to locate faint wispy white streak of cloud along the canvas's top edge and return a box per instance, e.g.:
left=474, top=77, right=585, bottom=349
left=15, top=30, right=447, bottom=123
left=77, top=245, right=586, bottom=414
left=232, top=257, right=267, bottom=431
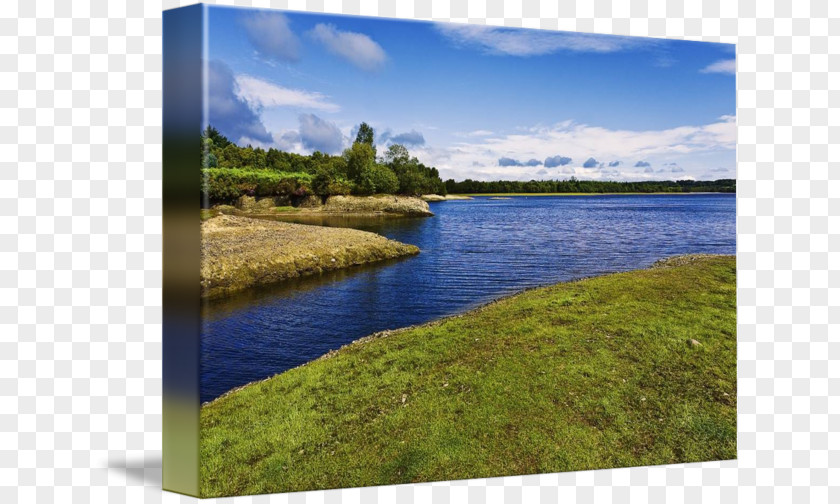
left=435, top=23, right=659, bottom=56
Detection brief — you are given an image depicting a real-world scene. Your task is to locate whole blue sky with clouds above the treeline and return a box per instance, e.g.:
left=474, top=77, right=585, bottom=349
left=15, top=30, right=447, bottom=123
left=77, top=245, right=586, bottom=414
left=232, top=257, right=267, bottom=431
left=207, top=6, right=736, bottom=180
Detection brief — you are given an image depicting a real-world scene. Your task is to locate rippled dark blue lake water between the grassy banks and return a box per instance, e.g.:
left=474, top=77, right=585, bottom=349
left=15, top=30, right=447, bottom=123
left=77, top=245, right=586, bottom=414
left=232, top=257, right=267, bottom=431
left=201, top=194, right=735, bottom=401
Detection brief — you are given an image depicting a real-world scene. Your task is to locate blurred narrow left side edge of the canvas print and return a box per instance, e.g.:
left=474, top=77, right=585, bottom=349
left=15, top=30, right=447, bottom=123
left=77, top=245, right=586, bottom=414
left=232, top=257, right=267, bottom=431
left=162, top=4, right=205, bottom=496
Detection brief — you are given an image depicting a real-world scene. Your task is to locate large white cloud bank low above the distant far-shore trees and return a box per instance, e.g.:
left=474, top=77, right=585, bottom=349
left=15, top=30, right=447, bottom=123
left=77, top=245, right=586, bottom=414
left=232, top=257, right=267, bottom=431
left=412, top=116, right=736, bottom=180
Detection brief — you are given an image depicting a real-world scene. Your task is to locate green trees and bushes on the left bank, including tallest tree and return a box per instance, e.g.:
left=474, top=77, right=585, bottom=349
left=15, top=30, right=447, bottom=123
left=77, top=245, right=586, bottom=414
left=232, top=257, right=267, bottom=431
left=201, top=123, right=446, bottom=203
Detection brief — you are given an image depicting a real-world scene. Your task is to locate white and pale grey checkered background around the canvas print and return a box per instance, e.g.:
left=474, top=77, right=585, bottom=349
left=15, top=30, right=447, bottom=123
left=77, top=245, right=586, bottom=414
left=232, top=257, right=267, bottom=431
left=0, top=0, right=840, bottom=503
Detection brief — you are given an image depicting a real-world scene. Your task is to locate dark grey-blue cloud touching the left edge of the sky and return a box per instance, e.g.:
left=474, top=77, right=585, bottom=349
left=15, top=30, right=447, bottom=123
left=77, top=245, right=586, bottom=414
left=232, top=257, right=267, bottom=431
left=207, top=60, right=272, bottom=143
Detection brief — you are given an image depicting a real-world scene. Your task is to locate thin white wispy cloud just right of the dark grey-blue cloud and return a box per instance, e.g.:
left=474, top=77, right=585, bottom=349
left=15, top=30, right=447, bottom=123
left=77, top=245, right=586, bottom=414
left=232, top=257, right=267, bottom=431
left=231, top=75, right=340, bottom=112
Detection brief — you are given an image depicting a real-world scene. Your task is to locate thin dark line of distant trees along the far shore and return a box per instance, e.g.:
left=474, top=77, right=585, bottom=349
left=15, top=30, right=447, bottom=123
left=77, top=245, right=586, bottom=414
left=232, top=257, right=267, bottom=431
left=445, top=177, right=735, bottom=194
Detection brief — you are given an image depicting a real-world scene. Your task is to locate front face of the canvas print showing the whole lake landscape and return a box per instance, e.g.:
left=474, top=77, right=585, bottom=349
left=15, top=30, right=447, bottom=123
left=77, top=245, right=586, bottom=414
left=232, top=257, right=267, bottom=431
left=164, top=6, right=737, bottom=497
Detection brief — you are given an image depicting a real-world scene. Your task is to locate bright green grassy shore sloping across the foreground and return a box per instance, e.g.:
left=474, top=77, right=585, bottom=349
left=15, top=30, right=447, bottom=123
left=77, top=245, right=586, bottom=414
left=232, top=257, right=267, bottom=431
left=201, top=256, right=736, bottom=497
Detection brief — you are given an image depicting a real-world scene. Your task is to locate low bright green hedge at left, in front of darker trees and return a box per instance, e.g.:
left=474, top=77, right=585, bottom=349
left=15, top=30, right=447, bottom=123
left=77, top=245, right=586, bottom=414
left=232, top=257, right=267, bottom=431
left=201, top=168, right=312, bottom=203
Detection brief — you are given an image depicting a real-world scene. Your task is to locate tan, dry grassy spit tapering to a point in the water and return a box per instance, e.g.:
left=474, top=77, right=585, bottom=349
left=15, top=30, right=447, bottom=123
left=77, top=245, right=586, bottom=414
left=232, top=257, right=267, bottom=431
left=201, top=214, right=420, bottom=298
